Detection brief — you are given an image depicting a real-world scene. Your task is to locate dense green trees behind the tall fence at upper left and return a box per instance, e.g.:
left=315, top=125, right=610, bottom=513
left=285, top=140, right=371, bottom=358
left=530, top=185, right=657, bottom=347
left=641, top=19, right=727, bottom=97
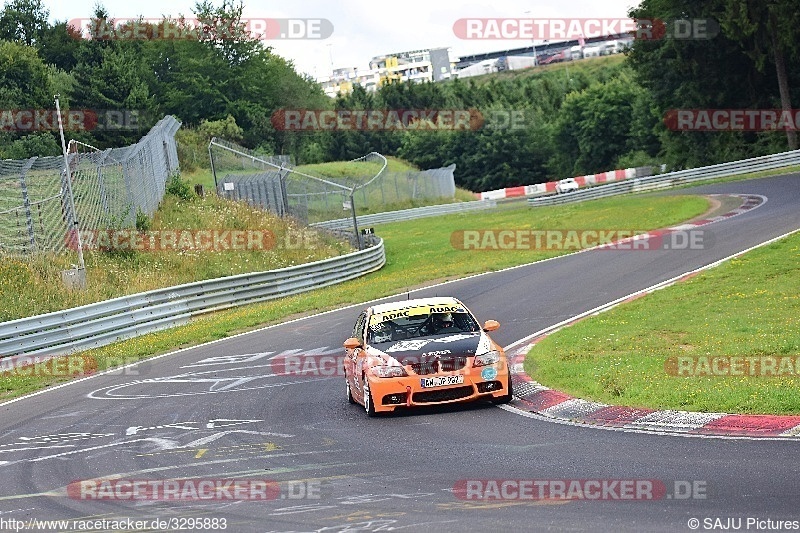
left=0, top=0, right=329, bottom=158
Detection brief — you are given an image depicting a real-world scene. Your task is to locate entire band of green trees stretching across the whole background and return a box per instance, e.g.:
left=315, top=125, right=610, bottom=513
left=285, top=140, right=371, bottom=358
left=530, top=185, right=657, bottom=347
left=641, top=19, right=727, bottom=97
left=0, top=0, right=800, bottom=190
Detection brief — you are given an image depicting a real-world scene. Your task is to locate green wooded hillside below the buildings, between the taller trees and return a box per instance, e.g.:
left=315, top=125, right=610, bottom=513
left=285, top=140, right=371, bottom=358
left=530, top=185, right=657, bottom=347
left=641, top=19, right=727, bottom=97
left=325, top=62, right=659, bottom=190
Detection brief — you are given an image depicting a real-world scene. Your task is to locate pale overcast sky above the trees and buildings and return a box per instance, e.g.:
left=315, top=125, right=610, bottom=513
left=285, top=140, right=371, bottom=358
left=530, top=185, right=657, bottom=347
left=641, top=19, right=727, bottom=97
left=44, top=0, right=639, bottom=76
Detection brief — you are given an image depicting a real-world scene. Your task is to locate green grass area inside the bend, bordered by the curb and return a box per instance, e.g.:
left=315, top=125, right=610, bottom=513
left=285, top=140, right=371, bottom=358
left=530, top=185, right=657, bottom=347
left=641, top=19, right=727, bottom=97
left=525, top=233, right=800, bottom=415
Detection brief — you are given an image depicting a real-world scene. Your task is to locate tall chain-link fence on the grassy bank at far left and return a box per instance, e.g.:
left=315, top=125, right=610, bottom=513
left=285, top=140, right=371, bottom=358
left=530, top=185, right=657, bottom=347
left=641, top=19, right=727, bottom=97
left=0, top=116, right=180, bottom=257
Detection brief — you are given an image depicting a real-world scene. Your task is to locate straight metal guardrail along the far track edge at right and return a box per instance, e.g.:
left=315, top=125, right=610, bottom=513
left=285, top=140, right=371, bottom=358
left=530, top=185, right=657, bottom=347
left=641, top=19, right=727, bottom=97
left=528, top=150, right=800, bottom=206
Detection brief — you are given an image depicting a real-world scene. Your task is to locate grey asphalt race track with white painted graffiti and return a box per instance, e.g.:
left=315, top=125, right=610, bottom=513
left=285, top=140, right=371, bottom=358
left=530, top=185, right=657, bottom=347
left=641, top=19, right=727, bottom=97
left=0, top=175, right=800, bottom=532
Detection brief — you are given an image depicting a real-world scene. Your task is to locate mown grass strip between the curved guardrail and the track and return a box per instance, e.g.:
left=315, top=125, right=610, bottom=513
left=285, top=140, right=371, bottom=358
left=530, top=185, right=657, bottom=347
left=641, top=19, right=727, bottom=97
left=0, top=196, right=708, bottom=399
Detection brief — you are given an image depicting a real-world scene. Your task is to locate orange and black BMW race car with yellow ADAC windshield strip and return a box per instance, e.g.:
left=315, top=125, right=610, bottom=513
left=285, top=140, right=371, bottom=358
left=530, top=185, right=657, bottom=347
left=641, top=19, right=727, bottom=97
left=344, top=297, right=512, bottom=416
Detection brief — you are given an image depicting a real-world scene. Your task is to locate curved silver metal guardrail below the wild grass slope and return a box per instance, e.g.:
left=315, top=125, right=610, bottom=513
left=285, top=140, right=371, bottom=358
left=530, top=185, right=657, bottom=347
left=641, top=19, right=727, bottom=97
left=0, top=238, right=386, bottom=358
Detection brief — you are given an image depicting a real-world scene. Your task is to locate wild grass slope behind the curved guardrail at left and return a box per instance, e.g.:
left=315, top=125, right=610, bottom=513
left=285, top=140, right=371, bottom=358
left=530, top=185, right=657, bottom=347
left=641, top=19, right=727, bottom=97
left=0, top=195, right=351, bottom=322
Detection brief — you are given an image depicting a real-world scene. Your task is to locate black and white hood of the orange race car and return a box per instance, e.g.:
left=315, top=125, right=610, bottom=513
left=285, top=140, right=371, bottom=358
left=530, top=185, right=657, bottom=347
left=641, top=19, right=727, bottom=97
left=372, top=332, right=491, bottom=366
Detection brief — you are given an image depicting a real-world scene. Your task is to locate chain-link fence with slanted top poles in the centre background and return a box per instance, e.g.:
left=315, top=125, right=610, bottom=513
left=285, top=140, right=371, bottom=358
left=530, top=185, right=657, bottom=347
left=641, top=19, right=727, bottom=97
left=209, top=138, right=455, bottom=223
